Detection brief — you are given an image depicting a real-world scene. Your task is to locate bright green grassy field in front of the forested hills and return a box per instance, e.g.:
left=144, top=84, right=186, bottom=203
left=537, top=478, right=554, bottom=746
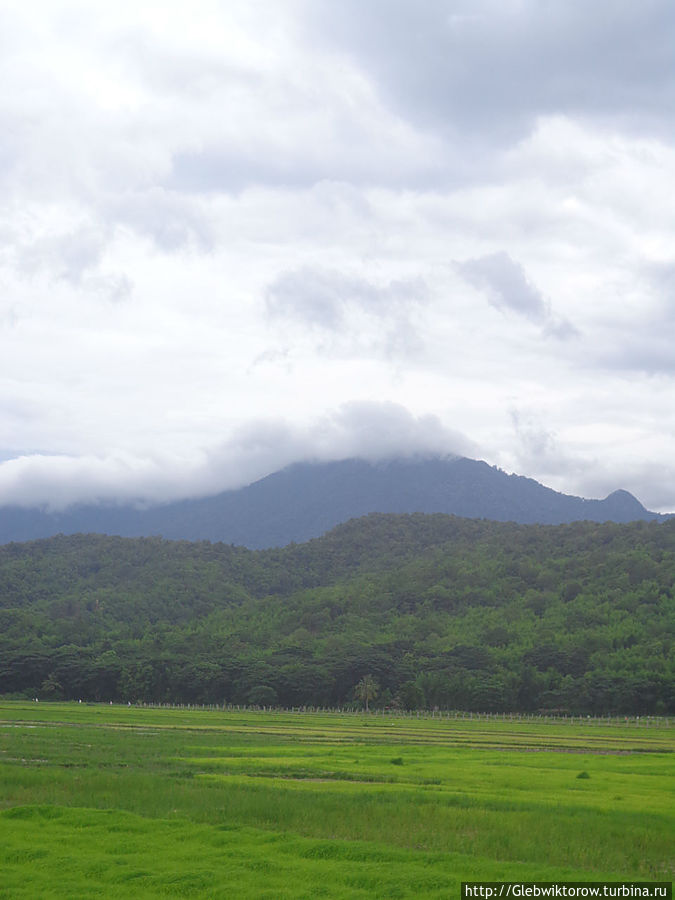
left=0, top=702, right=675, bottom=900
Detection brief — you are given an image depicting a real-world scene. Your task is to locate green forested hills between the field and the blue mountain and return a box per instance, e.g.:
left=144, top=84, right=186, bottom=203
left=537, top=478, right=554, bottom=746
left=0, top=514, right=675, bottom=715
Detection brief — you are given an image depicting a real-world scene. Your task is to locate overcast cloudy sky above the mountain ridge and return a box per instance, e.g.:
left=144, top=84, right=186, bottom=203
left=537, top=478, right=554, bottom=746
left=0, top=0, right=675, bottom=512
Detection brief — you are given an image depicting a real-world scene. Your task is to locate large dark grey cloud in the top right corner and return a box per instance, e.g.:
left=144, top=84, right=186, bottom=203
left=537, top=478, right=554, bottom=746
left=313, top=0, right=675, bottom=142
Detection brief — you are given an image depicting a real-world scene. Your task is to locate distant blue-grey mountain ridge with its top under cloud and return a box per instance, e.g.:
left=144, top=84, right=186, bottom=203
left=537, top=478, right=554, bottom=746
left=0, top=457, right=665, bottom=548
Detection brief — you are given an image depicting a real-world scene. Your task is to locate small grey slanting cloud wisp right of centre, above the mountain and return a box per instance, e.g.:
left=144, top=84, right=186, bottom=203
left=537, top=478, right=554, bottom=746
left=455, top=253, right=578, bottom=339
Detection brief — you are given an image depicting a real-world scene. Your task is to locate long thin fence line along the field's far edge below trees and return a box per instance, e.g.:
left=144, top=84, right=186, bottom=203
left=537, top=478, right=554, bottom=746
left=118, top=701, right=675, bottom=727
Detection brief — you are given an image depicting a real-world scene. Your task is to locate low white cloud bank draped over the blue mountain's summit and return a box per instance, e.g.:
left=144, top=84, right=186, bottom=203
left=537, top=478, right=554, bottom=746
left=0, top=401, right=476, bottom=510
